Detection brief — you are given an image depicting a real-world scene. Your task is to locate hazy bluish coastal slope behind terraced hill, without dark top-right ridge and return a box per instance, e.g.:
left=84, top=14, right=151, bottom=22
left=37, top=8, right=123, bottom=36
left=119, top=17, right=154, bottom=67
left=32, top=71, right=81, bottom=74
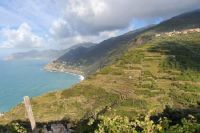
left=45, top=27, right=152, bottom=75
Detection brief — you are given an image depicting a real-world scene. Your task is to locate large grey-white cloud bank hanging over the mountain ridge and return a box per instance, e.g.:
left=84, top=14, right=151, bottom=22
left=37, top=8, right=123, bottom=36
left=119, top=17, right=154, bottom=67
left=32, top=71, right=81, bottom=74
left=53, top=0, right=200, bottom=38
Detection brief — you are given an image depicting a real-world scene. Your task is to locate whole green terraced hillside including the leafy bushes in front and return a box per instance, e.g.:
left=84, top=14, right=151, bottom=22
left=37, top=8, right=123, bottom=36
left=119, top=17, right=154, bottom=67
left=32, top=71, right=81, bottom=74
left=0, top=9, right=200, bottom=133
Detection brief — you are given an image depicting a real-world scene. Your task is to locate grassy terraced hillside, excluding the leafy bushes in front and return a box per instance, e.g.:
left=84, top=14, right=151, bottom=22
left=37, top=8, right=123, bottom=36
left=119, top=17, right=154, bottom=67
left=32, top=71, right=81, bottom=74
left=0, top=33, right=200, bottom=123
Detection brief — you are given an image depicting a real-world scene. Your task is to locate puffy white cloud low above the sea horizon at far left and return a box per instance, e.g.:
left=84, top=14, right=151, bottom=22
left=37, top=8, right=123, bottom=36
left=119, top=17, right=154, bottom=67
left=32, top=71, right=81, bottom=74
left=0, top=23, right=44, bottom=49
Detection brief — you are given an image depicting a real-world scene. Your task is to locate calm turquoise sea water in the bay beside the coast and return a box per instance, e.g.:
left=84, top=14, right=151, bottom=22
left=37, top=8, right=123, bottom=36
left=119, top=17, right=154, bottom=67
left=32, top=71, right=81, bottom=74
left=0, top=60, right=80, bottom=112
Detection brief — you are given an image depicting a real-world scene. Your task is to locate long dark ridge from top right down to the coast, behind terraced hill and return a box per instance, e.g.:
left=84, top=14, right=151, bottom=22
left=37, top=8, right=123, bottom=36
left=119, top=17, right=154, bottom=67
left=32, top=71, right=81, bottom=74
left=46, top=10, right=200, bottom=75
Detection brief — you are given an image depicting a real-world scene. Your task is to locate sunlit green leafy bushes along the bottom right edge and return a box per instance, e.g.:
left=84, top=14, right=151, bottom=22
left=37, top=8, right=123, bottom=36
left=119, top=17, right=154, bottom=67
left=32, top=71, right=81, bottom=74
left=89, top=115, right=200, bottom=133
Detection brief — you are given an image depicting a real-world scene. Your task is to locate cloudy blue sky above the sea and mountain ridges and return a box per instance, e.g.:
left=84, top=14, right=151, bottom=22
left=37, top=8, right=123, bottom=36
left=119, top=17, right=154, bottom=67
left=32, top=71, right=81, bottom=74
left=0, top=0, right=200, bottom=54
